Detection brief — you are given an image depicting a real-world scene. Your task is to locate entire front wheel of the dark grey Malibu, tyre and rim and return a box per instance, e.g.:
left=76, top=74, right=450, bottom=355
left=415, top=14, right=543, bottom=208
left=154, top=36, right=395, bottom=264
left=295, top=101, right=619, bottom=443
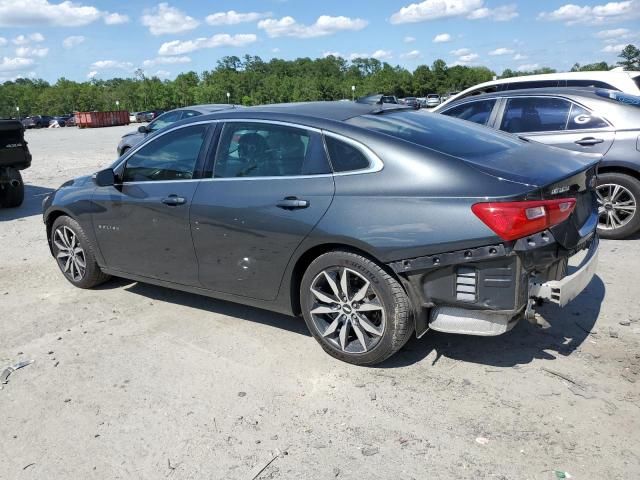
left=51, top=216, right=111, bottom=288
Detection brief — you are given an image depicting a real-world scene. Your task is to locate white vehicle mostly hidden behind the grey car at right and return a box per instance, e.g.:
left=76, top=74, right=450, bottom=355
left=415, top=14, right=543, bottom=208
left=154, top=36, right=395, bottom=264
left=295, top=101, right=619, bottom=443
left=436, top=70, right=640, bottom=111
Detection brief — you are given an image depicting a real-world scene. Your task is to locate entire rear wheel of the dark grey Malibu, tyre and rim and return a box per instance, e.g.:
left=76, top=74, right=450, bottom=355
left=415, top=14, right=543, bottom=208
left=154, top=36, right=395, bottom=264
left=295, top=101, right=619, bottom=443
left=300, top=250, right=413, bottom=365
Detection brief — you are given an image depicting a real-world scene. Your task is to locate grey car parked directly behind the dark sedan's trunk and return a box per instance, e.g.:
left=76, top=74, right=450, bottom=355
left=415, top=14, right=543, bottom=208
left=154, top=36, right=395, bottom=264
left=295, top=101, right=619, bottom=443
left=440, top=88, right=640, bottom=239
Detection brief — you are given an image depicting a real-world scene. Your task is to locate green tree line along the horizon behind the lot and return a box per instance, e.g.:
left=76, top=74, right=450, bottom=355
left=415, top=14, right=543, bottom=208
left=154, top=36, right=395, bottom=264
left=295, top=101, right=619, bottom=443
left=0, top=45, right=640, bottom=117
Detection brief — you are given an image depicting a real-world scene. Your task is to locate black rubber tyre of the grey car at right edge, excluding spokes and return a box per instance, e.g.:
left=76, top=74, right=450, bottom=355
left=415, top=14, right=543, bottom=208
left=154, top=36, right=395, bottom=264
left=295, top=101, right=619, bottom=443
left=598, top=172, right=640, bottom=240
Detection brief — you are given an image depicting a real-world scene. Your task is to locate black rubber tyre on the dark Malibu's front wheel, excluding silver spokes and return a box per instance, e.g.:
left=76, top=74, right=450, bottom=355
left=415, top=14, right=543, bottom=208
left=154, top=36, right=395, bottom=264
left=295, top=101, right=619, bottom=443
left=51, top=215, right=111, bottom=288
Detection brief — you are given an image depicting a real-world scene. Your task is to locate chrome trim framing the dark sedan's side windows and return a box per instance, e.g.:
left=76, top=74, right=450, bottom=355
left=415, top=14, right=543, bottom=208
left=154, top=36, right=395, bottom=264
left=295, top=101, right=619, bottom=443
left=113, top=118, right=384, bottom=185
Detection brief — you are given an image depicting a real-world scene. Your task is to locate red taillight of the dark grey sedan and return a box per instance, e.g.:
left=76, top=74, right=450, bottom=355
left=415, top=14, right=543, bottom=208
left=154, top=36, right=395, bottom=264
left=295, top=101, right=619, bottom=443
left=471, top=198, right=576, bottom=240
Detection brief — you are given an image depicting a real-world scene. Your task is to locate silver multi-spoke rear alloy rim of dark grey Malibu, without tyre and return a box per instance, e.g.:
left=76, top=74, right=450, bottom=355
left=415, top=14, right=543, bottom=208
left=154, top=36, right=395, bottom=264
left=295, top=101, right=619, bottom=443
left=309, top=267, right=385, bottom=354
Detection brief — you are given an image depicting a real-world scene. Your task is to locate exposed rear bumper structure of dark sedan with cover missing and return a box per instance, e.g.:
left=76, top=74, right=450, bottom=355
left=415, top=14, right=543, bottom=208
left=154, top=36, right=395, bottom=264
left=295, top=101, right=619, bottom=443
left=390, top=231, right=599, bottom=337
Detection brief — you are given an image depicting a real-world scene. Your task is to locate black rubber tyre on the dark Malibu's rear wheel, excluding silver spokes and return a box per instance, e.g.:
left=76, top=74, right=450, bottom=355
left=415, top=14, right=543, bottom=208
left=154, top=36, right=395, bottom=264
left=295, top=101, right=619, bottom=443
left=300, top=250, right=414, bottom=365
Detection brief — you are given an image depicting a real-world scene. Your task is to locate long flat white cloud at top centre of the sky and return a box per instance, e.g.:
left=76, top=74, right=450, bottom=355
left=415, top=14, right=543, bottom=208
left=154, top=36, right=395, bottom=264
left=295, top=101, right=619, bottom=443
left=258, top=15, right=369, bottom=38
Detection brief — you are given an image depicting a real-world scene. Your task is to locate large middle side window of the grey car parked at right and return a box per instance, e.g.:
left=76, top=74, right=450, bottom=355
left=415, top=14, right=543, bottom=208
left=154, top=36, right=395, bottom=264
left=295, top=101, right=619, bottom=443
left=500, top=97, right=571, bottom=133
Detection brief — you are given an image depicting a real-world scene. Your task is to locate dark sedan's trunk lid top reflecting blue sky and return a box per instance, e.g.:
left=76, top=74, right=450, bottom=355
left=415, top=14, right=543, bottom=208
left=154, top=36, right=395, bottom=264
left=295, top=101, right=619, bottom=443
left=462, top=141, right=602, bottom=187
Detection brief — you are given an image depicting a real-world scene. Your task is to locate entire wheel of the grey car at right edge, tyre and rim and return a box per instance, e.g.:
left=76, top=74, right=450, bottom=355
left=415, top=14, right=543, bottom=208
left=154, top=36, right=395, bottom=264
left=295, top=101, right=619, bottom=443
left=596, top=172, right=640, bottom=240
